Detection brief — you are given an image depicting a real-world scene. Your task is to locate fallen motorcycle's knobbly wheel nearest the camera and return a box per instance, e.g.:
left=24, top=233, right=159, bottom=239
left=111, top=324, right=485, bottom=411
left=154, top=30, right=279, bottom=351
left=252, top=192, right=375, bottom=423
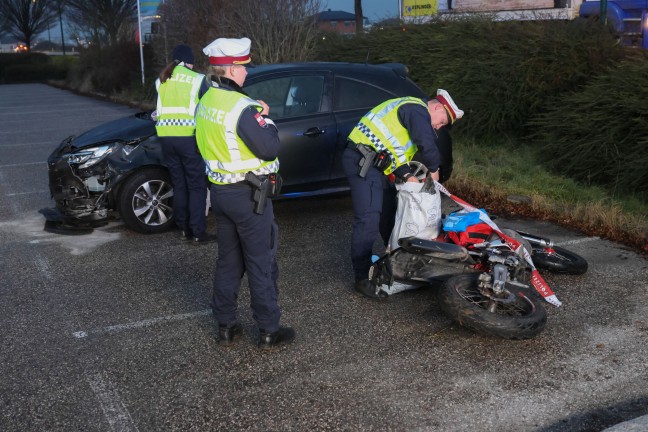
left=438, top=273, right=547, bottom=339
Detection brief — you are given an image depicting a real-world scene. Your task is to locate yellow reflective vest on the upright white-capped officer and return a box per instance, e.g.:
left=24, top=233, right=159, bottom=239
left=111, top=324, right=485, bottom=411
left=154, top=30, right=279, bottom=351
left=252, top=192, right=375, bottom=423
left=196, top=87, right=279, bottom=184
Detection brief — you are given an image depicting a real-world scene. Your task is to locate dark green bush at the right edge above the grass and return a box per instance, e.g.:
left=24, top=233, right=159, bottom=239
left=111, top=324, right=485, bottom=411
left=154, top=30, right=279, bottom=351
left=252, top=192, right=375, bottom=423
left=530, top=52, right=648, bottom=198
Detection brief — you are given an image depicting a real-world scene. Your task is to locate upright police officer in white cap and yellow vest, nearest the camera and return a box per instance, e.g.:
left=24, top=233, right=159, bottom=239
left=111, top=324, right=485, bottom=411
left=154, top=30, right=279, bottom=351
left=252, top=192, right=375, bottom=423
left=196, top=38, right=295, bottom=349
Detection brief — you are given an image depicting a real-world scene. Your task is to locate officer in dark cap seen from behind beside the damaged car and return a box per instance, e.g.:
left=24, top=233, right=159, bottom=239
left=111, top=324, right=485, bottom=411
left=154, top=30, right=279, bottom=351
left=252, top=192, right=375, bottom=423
left=155, top=45, right=214, bottom=245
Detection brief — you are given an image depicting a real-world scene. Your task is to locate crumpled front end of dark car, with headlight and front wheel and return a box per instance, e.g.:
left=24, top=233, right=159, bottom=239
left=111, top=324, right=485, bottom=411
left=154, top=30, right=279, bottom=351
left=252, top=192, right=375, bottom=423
left=46, top=112, right=173, bottom=233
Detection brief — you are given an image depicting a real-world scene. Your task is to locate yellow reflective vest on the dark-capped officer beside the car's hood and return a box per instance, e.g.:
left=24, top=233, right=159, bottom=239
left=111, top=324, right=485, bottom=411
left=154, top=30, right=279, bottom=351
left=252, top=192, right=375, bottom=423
left=155, top=63, right=204, bottom=136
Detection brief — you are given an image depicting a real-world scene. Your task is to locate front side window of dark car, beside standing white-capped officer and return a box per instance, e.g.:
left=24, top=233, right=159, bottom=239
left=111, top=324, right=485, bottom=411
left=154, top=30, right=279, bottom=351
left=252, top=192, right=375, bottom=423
left=245, top=75, right=324, bottom=120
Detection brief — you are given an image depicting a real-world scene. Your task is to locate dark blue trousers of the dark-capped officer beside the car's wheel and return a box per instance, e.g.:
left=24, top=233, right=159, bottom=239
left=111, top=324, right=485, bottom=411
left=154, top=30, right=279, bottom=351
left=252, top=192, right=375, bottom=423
left=160, top=136, right=207, bottom=237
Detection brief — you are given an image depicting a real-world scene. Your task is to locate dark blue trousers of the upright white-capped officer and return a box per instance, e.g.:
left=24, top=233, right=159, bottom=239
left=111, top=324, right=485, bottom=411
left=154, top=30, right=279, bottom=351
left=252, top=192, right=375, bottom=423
left=211, top=182, right=281, bottom=332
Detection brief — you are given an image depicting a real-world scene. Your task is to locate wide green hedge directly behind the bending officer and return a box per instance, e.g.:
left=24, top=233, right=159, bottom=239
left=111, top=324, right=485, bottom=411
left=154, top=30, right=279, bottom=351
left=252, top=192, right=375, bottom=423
left=317, top=18, right=623, bottom=141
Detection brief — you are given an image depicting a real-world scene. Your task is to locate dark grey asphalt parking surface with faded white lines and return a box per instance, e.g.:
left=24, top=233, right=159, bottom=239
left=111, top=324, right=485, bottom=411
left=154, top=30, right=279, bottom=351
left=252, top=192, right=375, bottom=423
left=0, top=84, right=648, bottom=431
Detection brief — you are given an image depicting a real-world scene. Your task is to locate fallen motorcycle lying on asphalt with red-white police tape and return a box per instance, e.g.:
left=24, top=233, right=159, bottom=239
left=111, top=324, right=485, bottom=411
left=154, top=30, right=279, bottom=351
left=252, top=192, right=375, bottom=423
left=369, top=164, right=587, bottom=339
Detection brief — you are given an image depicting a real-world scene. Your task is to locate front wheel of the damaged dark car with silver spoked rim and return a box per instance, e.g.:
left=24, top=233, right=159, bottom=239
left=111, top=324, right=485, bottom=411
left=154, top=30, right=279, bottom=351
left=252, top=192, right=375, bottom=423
left=117, top=168, right=174, bottom=234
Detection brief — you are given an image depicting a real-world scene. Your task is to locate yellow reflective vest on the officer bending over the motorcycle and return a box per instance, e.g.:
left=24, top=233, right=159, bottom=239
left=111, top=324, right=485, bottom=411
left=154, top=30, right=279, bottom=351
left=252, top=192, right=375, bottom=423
left=349, top=97, right=427, bottom=174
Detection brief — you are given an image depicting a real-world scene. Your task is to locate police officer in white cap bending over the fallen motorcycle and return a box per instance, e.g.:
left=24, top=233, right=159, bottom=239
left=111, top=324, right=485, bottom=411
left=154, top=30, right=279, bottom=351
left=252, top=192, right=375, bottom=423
left=342, top=89, right=464, bottom=298
